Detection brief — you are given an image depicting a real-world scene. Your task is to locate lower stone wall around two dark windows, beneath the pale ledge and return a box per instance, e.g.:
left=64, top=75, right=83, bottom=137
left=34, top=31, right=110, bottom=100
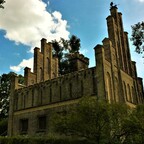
left=12, top=99, right=78, bottom=136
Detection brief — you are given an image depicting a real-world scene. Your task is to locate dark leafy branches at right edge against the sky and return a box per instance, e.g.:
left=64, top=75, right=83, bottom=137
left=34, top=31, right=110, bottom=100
left=131, top=22, right=144, bottom=53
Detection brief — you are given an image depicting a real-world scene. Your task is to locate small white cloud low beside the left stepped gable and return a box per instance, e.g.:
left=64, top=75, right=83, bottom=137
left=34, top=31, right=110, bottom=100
left=10, top=58, right=33, bottom=72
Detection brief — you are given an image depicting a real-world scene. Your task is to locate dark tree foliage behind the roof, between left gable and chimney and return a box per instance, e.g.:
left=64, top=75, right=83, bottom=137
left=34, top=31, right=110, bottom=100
left=52, top=35, right=80, bottom=75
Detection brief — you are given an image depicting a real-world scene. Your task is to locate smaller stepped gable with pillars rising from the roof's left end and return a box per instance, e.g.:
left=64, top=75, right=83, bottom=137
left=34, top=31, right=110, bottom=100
left=24, top=38, right=58, bottom=86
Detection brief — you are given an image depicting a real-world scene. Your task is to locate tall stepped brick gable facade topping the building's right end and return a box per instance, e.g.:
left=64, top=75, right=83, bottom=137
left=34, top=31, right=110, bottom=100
left=95, top=5, right=144, bottom=106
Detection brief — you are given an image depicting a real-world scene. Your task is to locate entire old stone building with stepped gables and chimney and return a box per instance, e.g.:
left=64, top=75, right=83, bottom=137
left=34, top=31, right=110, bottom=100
left=8, top=6, right=144, bottom=136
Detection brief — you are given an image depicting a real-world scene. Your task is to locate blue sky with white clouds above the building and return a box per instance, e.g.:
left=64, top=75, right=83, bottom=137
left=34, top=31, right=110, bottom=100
left=0, top=0, right=144, bottom=78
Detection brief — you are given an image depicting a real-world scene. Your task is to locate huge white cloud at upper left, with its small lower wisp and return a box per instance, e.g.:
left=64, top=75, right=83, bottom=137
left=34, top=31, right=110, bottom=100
left=0, top=0, right=69, bottom=72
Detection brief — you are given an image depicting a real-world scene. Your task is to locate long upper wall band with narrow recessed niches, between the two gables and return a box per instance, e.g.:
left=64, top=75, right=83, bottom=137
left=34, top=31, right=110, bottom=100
left=14, top=67, right=96, bottom=111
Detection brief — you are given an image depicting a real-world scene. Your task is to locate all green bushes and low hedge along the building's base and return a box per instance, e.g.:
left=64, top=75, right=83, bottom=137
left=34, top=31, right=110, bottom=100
left=0, top=97, right=144, bottom=144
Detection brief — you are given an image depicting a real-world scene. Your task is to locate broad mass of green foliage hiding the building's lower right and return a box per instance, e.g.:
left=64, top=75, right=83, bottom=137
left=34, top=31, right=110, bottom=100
left=52, top=98, right=144, bottom=144
